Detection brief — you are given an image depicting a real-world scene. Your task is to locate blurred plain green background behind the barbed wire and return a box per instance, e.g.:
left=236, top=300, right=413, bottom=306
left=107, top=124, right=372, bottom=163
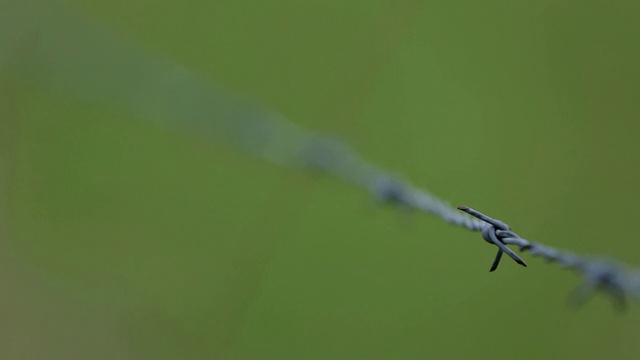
left=0, top=0, right=640, bottom=359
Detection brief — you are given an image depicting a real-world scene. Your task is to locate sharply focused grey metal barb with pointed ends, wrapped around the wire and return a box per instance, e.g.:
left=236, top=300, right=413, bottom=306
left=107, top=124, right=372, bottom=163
left=458, top=206, right=527, bottom=271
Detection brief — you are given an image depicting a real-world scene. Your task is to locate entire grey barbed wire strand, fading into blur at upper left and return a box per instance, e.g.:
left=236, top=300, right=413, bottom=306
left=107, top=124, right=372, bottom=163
left=6, top=0, right=640, bottom=307
